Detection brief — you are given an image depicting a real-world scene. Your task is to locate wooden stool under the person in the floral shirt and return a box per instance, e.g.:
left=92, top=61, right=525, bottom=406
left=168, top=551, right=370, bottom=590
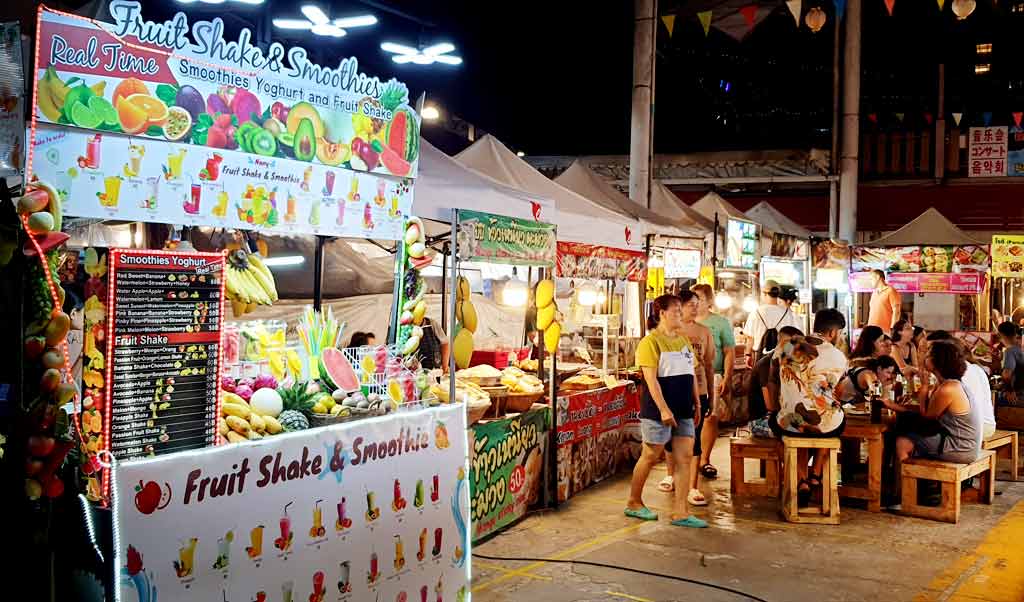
left=782, top=437, right=840, bottom=524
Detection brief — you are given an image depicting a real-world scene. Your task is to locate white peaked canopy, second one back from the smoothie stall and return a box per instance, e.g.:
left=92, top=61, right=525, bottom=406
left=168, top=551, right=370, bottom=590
left=454, top=135, right=644, bottom=249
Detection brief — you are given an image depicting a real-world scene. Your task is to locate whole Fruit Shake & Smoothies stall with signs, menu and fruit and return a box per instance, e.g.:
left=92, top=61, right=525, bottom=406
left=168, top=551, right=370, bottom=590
left=18, top=3, right=469, bottom=602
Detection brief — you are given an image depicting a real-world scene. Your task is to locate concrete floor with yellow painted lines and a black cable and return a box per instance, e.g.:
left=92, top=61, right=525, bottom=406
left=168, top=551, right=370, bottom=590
left=473, top=438, right=1024, bottom=602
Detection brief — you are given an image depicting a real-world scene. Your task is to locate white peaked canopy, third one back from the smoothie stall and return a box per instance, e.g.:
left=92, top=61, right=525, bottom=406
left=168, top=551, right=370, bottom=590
left=555, top=160, right=711, bottom=239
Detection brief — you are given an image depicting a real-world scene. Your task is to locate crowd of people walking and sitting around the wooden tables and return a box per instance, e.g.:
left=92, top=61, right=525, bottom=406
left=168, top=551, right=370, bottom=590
left=625, top=272, right=1024, bottom=528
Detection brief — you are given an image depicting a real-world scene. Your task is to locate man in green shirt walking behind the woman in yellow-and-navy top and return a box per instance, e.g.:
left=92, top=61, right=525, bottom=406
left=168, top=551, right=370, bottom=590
left=692, top=285, right=736, bottom=479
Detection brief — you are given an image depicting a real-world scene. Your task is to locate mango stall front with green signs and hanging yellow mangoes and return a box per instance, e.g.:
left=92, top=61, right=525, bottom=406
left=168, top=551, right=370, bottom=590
left=441, top=210, right=561, bottom=541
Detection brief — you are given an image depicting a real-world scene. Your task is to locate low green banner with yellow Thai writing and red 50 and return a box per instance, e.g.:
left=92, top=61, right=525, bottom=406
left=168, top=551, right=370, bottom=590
left=469, top=407, right=551, bottom=542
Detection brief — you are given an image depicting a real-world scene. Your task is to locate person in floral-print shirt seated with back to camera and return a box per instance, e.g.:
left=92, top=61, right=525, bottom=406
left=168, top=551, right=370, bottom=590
left=771, top=308, right=848, bottom=500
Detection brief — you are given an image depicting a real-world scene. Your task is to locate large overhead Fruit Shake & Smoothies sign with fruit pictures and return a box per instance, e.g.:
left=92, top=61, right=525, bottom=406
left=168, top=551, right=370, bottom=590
left=30, top=0, right=420, bottom=239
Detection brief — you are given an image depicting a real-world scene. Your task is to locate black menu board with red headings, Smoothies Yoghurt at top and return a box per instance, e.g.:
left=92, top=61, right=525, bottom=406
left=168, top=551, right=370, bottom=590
left=103, top=249, right=224, bottom=460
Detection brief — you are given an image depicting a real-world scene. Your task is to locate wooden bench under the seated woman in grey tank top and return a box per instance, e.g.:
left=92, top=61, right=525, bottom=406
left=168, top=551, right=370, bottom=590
left=900, top=449, right=995, bottom=523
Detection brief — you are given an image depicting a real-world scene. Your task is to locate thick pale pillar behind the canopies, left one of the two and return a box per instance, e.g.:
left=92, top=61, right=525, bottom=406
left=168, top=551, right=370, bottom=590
left=630, top=0, right=657, bottom=208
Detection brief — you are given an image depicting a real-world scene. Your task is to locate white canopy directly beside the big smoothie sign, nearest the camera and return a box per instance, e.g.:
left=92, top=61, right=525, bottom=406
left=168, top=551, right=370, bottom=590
left=413, top=138, right=556, bottom=227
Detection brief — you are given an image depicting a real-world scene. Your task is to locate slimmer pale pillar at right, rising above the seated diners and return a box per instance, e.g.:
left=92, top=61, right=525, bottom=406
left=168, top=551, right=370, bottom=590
left=839, top=0, right=860, bottom=243
